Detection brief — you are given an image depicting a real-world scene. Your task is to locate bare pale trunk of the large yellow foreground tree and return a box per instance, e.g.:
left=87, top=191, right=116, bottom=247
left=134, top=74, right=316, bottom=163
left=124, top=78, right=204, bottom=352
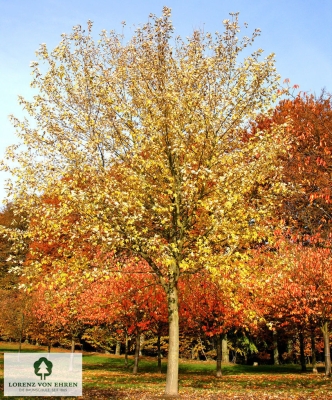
left=165, top=282, right=179, bottom=396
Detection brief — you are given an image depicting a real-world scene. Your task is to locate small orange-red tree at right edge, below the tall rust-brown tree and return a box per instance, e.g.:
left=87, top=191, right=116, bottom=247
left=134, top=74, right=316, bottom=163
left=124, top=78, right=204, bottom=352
left=252, top=239, right=332, bottom=376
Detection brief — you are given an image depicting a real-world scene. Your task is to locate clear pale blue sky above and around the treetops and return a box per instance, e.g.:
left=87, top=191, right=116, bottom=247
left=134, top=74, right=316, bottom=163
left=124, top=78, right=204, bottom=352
left=0, top=0, right=332, bottom=201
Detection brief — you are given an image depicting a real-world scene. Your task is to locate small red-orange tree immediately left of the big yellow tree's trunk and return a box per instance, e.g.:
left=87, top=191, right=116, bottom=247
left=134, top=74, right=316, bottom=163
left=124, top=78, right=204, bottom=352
left=81, top=260, right=167, bottom=373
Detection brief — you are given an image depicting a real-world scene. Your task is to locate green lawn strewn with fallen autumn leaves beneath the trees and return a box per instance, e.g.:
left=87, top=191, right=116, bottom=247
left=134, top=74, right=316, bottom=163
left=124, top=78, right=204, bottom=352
left=0, top=343, right=332, bottom=400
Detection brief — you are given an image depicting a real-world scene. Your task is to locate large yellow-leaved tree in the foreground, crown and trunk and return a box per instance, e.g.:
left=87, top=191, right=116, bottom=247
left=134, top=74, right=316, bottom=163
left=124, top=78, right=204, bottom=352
left=3, top=7, right=283, bottom=395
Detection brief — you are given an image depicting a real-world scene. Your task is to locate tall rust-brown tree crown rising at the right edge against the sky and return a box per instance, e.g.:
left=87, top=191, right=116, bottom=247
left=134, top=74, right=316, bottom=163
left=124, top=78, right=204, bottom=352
left=254, top=92, right=332, bottom=241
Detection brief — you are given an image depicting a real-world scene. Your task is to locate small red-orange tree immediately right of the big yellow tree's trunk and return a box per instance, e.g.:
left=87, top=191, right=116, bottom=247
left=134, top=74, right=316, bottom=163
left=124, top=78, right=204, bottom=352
left=179, top=268, right=252, bottom=377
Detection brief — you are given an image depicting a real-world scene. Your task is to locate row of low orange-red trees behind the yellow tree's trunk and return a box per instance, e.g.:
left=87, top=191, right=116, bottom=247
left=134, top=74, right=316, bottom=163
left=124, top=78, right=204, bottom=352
left=0, top=209, right=332, bottom=374
